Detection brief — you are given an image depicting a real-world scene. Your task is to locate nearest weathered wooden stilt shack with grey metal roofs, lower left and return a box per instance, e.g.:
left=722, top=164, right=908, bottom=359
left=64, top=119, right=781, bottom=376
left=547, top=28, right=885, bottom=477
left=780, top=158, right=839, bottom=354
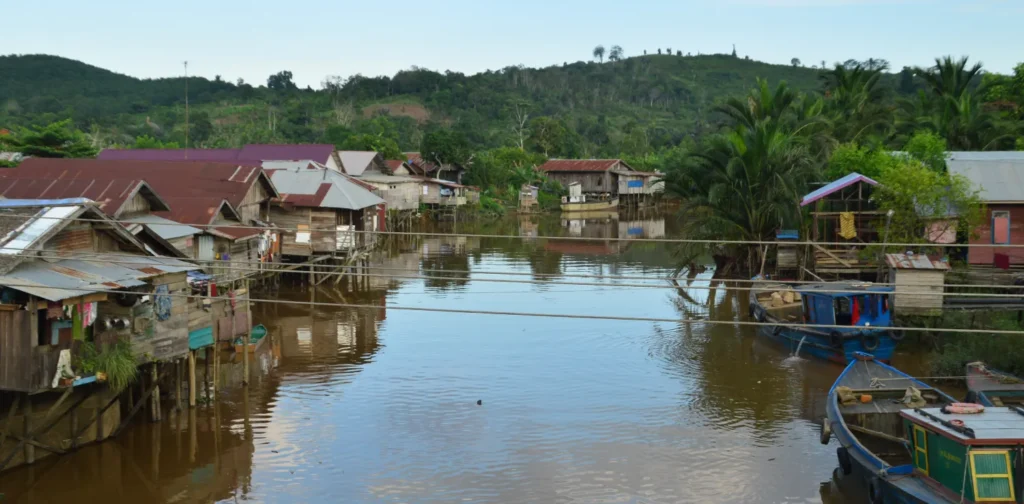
left=0, top=199, right=198, bottom=470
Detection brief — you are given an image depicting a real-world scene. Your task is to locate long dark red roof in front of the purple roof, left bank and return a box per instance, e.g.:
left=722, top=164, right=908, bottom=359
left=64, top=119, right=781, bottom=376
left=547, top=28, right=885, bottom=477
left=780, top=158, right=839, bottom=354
left=7, top=158, right=278, bottom=214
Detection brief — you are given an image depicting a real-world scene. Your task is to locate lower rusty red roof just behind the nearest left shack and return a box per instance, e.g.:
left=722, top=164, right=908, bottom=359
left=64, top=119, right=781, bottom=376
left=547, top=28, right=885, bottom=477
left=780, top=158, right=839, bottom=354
left=0, top=178, right=168, bottom=217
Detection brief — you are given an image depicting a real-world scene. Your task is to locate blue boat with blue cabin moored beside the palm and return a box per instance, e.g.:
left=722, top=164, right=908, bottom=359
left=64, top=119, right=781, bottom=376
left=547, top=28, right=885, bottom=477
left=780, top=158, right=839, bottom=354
left=750, top=282, right=903, bottom=365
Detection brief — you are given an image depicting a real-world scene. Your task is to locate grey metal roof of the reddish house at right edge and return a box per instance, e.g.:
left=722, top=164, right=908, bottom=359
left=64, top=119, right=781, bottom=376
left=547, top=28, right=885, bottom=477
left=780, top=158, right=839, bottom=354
left=946, top=152, right=1024, bottom=203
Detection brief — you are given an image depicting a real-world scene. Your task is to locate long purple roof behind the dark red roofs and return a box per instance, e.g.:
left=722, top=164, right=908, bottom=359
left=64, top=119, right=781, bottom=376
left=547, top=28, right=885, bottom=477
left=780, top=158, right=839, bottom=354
left=96, top=143, right=342, bottom=171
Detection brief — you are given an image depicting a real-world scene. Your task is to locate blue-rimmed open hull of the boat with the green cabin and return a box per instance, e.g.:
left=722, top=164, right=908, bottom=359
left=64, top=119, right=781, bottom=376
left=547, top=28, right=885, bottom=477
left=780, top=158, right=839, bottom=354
left=820, top=353, right=966, bottom=503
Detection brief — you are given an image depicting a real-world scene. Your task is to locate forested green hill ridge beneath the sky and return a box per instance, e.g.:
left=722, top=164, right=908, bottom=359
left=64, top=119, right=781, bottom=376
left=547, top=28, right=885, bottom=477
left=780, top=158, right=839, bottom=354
left=0, top=54, right=909, bottom=156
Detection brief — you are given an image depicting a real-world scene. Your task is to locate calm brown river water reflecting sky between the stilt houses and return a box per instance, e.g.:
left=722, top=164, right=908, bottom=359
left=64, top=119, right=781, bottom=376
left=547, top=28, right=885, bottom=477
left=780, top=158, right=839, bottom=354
left=0, top=211, right=937, bottom=504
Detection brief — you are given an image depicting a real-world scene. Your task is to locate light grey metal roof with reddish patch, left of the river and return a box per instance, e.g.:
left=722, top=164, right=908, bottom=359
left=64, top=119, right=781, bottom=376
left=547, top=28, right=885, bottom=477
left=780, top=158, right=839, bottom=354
left=270, top=169, right=384, bottom=210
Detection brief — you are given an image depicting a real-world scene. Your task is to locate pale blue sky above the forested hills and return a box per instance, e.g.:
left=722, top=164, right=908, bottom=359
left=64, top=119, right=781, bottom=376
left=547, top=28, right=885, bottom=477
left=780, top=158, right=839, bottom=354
left=0, top=0, right=1024, bottom=88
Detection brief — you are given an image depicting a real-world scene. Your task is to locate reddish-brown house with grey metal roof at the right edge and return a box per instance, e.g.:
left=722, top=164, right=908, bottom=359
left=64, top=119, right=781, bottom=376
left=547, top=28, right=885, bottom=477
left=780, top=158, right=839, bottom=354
left=946, top=152, right=1024, bottom=268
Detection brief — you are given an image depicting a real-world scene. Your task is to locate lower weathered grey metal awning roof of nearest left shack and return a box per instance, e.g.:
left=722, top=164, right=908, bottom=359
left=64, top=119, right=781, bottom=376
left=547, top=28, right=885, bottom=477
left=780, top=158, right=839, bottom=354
left=0, top=254, right=199, bottom=301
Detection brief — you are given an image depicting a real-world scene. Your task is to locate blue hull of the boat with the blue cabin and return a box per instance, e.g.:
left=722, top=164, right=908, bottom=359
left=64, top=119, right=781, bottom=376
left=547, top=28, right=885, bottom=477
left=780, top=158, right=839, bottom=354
left=758, top=321, right=896, bottom=365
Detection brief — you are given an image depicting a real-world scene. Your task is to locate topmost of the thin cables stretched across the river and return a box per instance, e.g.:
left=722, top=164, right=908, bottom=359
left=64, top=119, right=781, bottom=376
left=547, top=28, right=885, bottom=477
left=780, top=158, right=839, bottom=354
left=0, top=213, right=1024, bottom=249
